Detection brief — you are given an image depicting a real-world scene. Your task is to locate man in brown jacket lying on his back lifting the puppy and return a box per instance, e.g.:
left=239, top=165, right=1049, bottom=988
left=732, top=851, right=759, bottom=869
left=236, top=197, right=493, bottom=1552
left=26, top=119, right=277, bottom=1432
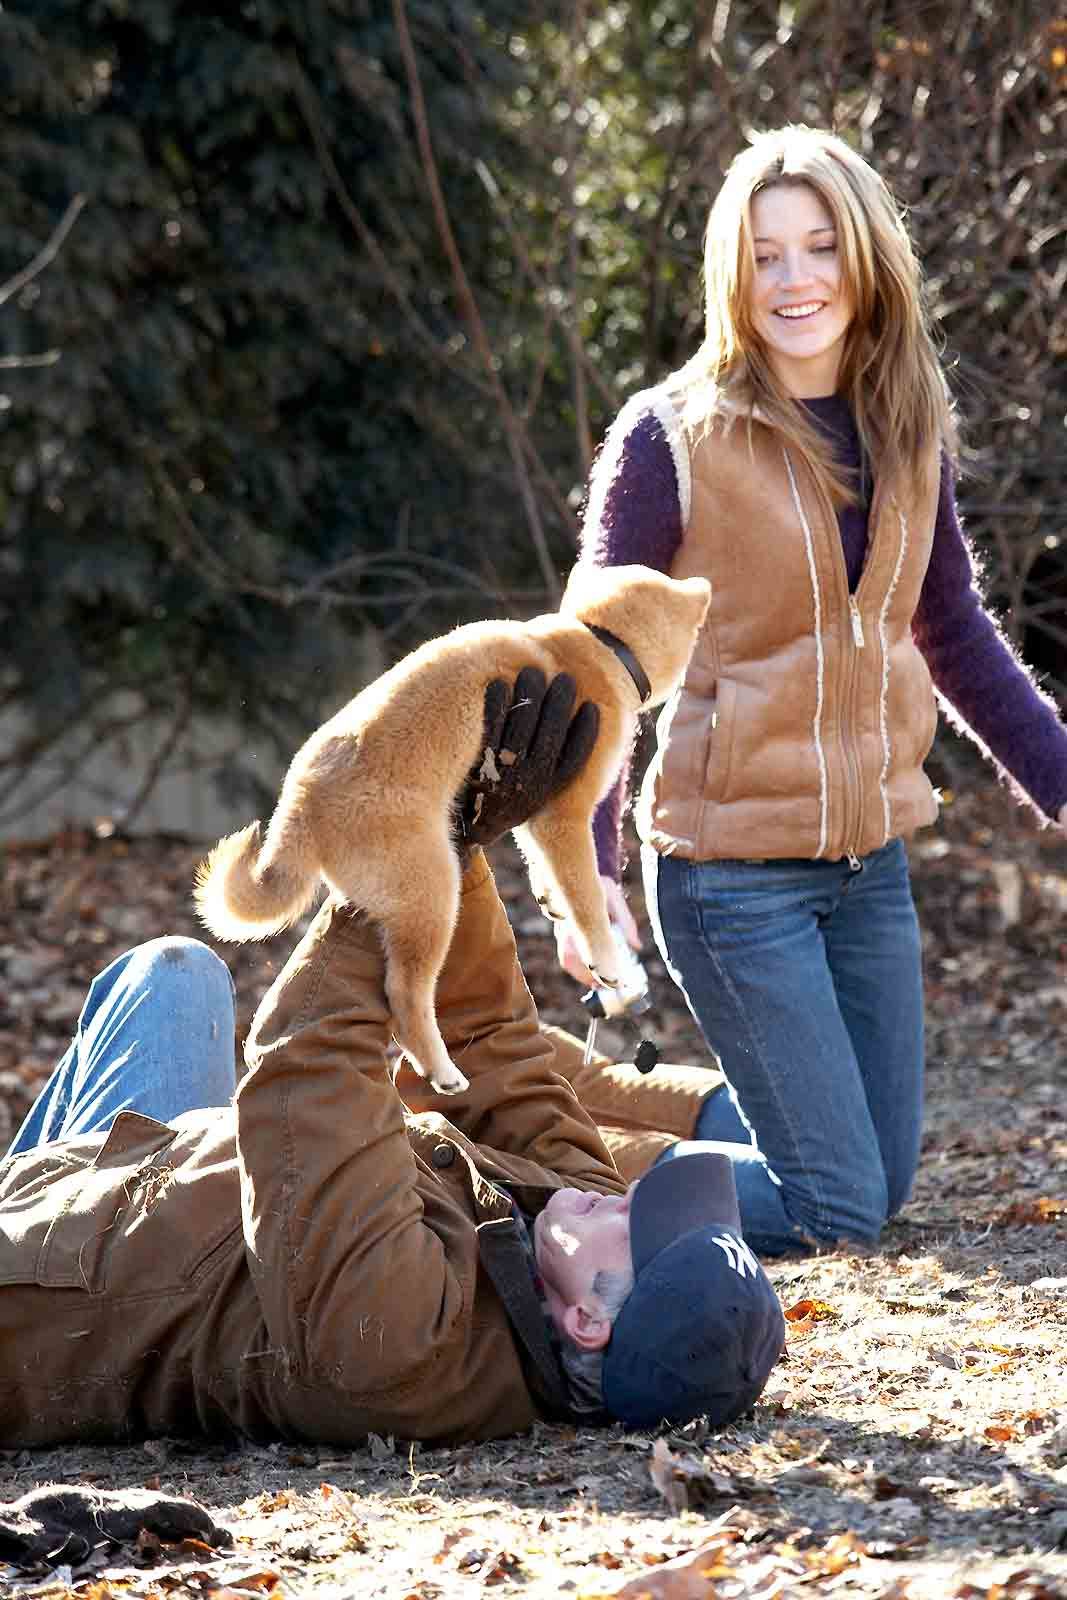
left=0, top=668, right=784, bottom=1448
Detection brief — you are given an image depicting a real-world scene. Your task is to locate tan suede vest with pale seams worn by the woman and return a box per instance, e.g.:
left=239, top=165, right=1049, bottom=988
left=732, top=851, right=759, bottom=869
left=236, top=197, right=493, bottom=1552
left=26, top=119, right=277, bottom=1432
left=637, top=400, right=939, bottom=861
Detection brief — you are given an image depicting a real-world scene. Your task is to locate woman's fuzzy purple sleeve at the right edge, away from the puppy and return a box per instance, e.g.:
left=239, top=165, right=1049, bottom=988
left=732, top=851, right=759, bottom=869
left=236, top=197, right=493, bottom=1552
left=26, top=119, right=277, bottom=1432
left=912, top=461, right=1067, bottom=819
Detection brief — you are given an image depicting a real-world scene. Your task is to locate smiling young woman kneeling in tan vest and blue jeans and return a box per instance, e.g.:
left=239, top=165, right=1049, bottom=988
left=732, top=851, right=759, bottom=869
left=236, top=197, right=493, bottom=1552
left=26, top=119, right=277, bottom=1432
left=560, top=126, right=1067, bottom=1253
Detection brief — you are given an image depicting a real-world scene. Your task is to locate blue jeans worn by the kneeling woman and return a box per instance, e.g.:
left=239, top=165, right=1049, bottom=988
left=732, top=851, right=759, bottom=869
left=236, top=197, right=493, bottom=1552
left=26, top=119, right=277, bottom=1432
left=643, top=840, right=923, bottom=1254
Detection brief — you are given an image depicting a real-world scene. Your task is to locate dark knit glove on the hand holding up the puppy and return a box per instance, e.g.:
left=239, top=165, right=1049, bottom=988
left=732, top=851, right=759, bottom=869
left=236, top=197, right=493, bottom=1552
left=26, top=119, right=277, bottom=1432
left=454, top=667, right=600, bottom=856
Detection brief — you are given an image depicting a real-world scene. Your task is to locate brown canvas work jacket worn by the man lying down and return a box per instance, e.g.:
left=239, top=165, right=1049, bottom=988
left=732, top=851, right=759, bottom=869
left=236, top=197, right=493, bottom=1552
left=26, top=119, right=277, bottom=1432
left=0, top=854, right=716, bottom=1448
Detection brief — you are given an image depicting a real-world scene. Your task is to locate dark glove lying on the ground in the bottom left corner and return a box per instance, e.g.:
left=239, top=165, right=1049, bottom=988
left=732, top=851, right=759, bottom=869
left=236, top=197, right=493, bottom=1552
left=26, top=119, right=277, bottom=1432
left=0, top=1485, right=234, bottom=1571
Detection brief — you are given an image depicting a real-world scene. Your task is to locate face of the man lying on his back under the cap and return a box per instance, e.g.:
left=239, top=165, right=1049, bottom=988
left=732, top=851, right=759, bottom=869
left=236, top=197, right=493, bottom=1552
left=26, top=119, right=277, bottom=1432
left=533, top=1184, right=637, bottom=1349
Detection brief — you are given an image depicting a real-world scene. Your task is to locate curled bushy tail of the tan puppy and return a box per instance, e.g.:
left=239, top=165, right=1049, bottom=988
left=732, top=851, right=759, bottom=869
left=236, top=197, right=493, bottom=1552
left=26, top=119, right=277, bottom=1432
left=194, top=822, right=318, bottom=942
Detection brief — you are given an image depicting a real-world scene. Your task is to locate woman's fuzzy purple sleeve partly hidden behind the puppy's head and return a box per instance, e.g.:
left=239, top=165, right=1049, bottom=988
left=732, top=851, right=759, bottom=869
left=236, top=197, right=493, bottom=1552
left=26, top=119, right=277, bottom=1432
left=579, top=408, right=681, bottom=878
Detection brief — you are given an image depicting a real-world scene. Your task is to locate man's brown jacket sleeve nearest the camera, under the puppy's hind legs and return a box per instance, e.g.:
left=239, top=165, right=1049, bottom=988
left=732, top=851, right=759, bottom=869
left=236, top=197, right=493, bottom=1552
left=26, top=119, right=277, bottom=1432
left=235, top=902, right=470, bottom=1390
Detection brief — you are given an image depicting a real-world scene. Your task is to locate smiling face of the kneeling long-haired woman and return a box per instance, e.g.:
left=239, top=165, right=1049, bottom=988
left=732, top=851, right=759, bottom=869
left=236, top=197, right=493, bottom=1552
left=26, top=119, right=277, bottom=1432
left=749, top=182, right=853, bottom=400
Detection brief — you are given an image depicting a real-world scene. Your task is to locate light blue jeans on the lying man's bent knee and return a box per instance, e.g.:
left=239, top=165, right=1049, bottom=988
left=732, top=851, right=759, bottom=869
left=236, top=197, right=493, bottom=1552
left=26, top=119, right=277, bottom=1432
left=8, top=938, right=235, bottom=1155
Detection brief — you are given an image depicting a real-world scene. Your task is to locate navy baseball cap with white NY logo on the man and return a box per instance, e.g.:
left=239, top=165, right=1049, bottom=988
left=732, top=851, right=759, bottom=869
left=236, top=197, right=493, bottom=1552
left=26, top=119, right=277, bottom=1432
left=601, top=1147, right=785, bottom=1427
